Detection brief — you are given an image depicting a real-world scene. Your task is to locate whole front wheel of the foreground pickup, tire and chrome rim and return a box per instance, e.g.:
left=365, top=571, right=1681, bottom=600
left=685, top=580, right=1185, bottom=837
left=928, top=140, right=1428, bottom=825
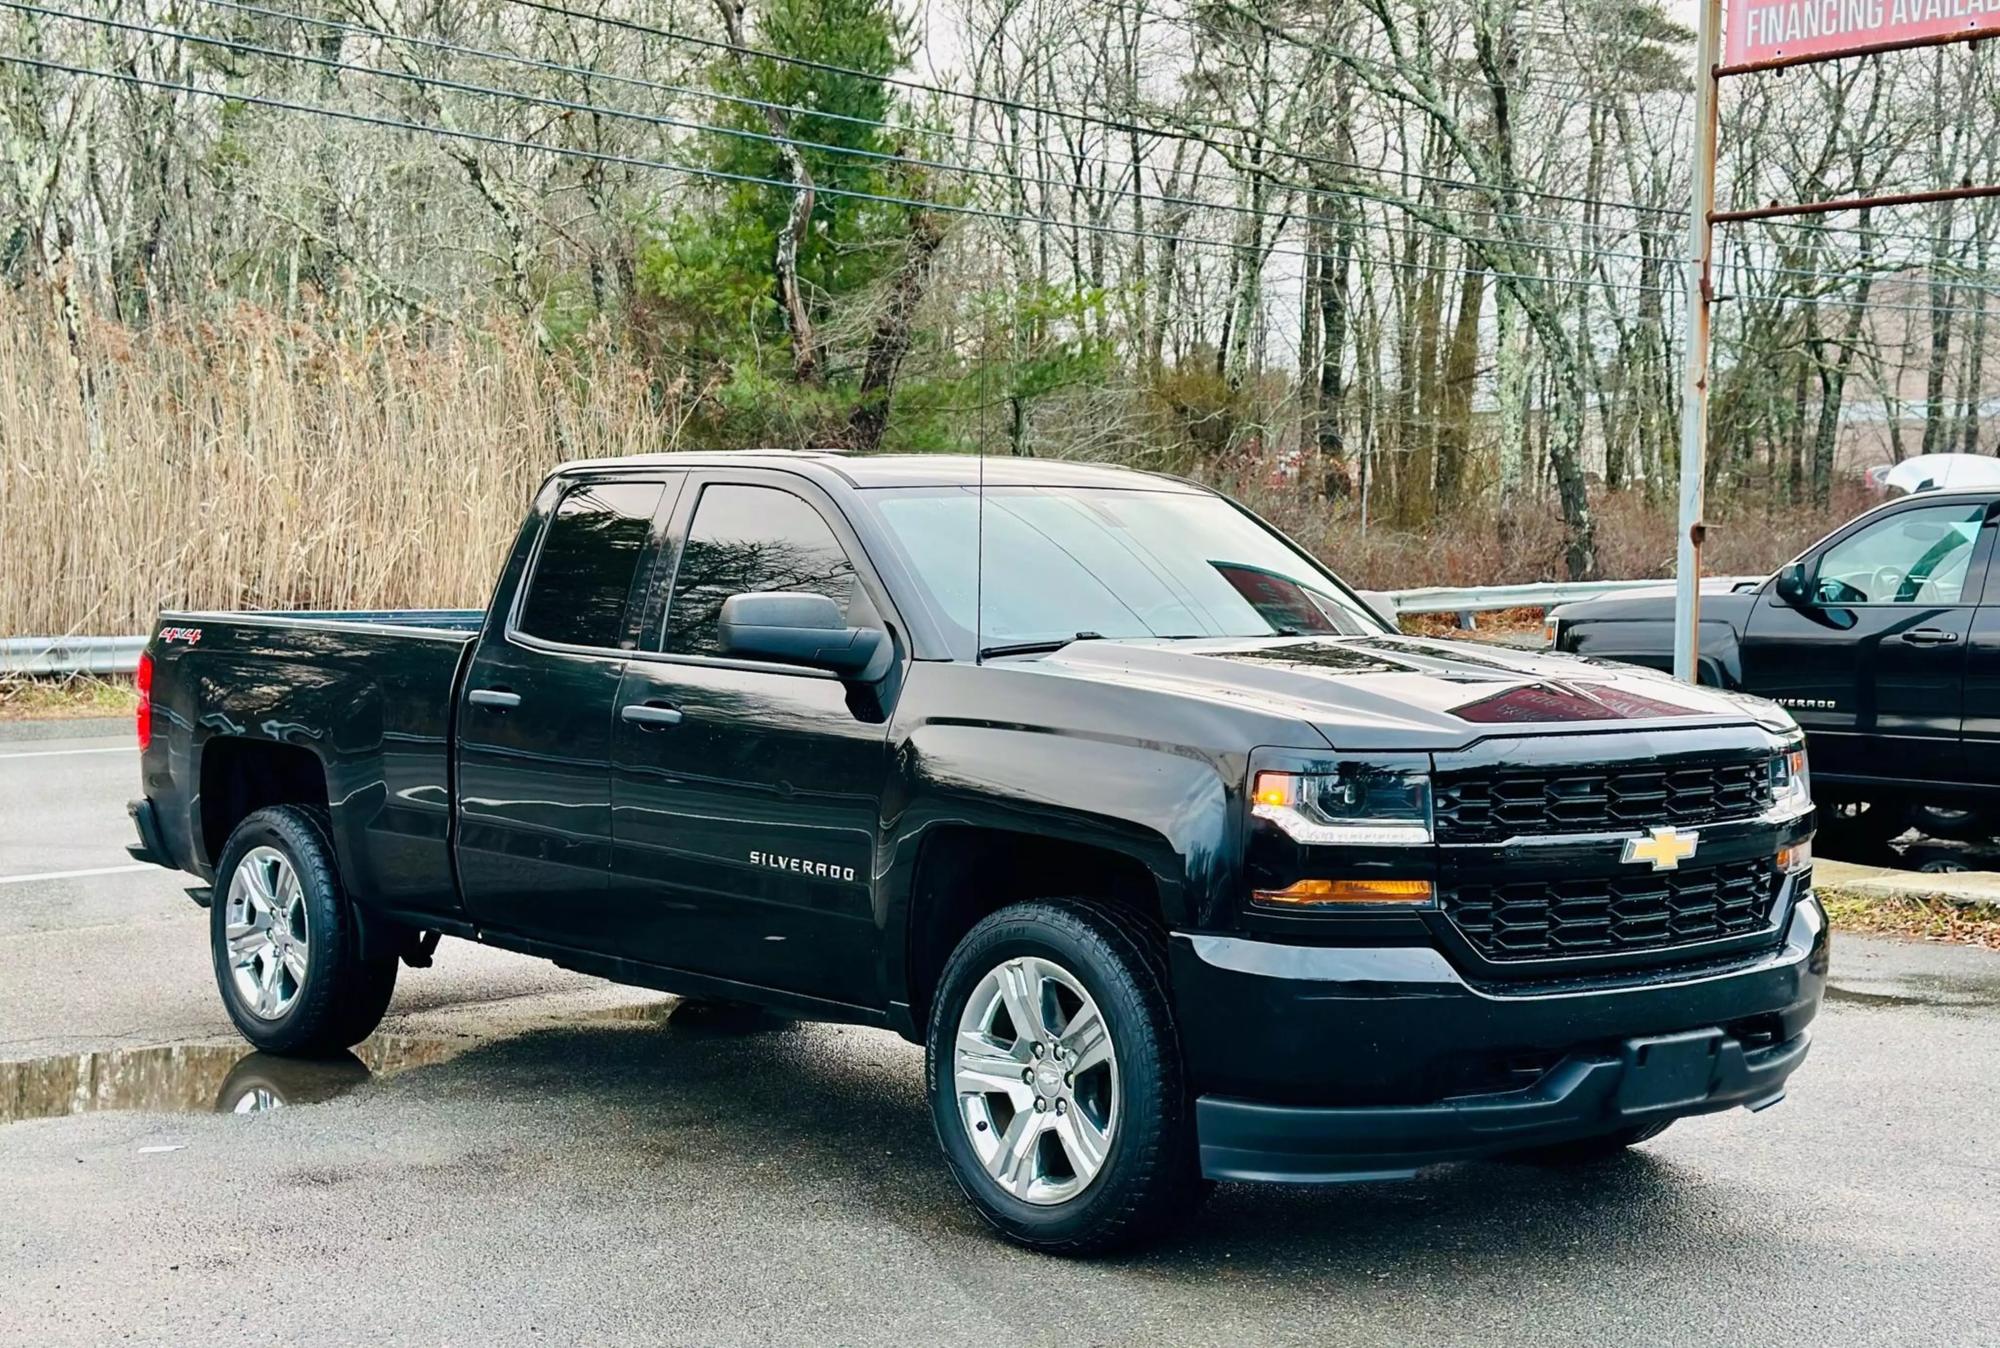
left=926, top=900, right=1204, bottom=1254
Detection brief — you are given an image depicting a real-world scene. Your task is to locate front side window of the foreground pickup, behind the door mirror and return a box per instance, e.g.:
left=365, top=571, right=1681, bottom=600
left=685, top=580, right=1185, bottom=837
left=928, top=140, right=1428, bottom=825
left=662, top=484, right=856, bottom=656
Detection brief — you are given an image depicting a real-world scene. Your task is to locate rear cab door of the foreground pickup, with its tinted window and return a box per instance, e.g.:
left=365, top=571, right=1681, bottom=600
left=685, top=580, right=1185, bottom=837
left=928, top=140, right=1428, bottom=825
left=458, top=474, right=682, bottom=950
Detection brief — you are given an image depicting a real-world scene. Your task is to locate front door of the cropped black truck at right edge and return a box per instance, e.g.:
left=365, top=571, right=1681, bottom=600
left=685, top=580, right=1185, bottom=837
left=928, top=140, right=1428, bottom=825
left=1742, top=498, right=1994, bottom=780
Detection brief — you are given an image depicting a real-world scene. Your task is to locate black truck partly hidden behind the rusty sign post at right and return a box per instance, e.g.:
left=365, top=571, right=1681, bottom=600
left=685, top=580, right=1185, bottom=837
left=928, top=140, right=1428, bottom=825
left=1550, top=488, right=2000, bottom=842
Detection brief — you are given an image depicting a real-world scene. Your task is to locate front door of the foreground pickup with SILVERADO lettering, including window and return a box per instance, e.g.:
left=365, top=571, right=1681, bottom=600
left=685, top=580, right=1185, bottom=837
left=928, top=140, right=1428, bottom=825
left=612, top=470, right=902, bottom=1006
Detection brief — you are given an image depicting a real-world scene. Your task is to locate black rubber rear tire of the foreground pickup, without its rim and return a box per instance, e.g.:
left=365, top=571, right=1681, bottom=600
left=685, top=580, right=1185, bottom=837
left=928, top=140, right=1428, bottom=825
left=208, top=806, right=396, bottom=1058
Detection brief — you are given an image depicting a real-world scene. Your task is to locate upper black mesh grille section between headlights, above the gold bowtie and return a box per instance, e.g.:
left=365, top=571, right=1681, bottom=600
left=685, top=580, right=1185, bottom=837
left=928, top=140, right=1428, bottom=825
left=1436, top=756, right=1772, bottom=842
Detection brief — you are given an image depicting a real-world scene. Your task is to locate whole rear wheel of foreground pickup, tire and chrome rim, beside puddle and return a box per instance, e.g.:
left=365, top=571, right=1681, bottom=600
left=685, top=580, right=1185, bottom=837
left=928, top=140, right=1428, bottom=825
left=208, top=806, right=396, bottom=1056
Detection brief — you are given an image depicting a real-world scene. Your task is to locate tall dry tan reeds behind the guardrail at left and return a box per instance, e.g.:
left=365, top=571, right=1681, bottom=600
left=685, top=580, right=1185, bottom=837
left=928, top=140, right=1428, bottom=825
left=0, top=292, right=678, bottom=634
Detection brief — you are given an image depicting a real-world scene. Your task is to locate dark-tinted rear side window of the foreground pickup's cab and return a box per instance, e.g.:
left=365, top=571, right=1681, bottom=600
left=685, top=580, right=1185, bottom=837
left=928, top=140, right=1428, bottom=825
left=514, top=482, right=666, bottom=650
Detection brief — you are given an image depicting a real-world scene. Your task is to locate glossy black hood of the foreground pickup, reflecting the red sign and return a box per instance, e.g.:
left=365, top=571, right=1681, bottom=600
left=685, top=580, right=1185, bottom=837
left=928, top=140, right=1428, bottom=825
left=1034, top=636, right=1792, bottom=750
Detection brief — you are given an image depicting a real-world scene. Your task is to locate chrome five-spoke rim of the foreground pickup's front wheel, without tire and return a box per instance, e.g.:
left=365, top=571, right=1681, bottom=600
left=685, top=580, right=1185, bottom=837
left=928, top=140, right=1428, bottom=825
left=952, top=956, right=1118, bottom=1206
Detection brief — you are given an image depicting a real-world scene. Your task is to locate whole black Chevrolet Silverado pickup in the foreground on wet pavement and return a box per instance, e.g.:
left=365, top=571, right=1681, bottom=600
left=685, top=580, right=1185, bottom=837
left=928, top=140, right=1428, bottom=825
left=132, top=452, right=1828, bottom=1252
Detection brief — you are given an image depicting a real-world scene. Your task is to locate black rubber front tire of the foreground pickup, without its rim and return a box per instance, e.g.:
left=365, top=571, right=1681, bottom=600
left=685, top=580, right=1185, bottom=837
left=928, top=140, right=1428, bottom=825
left=924, top=898, right=1210, bottom=1256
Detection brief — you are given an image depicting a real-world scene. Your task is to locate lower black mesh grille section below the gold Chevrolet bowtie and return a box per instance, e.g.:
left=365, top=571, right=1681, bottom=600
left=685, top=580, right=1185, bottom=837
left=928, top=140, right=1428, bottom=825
left=1440, top=858, right=1784, bottom=960
